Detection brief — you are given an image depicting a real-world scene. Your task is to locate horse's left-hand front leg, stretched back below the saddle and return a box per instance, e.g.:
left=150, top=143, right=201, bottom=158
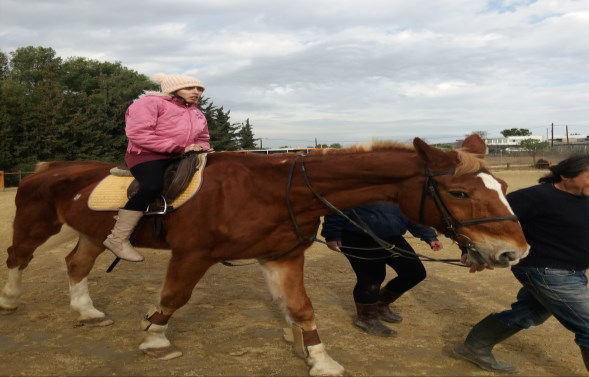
left=139, top=251, right=215, bottom=360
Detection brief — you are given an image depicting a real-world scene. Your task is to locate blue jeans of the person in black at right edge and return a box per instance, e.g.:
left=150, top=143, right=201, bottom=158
left=496, top=266, right=589, bottom=347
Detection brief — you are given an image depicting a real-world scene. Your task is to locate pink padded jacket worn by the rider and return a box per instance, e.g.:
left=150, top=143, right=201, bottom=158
left=125, top=92, right=210, bottom=154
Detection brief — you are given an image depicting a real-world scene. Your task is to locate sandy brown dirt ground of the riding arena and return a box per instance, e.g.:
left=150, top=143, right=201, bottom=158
left=0, top=171, right=586, bottom=376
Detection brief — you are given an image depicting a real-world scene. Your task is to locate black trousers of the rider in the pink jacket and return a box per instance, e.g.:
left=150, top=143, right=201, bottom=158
left=124, top=159, right=173, bottom=211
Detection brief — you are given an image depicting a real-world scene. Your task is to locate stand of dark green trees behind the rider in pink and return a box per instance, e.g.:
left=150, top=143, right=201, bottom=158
left=0, top=46, right=253, bottom=171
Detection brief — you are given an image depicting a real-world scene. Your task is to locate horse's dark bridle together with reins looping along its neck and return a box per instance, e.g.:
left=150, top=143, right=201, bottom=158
left=286, top=154, right=517, bottom=262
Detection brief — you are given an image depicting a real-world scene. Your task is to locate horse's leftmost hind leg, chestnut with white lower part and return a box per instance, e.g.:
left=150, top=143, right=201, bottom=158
left=0, top=203, right=62, bottom=313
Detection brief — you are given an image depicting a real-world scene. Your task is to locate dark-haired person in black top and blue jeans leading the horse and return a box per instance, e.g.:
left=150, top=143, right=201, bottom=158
left=454, top=155, right=589, bottom=373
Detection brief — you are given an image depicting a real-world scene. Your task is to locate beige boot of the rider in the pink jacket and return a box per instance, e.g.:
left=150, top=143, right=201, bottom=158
left=102, top=209, right=143, bottom=262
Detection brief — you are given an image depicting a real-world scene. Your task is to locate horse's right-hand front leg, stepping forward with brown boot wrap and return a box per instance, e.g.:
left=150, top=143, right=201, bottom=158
left=260, top=251, right=344, bottom=376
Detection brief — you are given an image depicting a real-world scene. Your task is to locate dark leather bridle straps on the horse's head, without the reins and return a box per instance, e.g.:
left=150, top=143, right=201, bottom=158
left=419, top=165, right=518, bottom=254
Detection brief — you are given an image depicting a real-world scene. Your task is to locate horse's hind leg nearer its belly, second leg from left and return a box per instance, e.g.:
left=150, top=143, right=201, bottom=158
left=65, top=234, right=113, bottom=326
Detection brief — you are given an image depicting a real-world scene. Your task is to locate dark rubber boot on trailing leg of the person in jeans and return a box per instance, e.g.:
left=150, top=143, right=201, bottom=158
left=454, top=314, right=521, bottom=373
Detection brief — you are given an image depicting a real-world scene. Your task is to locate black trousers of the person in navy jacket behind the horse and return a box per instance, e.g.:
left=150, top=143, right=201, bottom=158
left=342, top=233, right=426, bottom=304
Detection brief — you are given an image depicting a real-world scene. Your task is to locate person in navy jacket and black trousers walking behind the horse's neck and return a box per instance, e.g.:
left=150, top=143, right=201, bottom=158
left=321, top=202, right=442, bottom=337
